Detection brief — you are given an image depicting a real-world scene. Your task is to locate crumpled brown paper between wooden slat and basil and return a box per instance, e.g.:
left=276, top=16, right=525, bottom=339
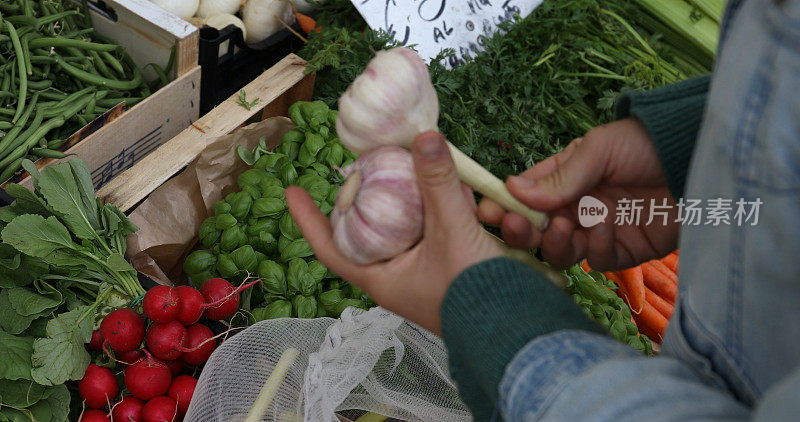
left=126, top=117, right=294, bottom=285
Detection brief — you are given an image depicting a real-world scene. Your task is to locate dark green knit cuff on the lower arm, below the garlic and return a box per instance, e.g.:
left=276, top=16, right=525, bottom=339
left=440, top=258, right=603, bottom=421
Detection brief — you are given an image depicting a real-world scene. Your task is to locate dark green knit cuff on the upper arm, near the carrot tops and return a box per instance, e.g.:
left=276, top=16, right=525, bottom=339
left=616, top=75, right=711, bottom=198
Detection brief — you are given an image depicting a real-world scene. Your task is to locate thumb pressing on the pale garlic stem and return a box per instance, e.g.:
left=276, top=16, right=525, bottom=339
left=506, top=138, right=604, bottom=211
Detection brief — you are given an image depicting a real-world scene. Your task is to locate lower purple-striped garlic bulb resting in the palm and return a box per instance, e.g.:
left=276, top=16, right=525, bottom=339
left=331, top=146, right=423, bottom=264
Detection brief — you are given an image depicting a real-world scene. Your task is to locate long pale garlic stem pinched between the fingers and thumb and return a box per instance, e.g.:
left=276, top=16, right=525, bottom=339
left=447, top=142, right=548, bottom=230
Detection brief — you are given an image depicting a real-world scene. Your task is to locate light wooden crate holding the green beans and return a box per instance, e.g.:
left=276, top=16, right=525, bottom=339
left=6, top=0, right=200, bottom=188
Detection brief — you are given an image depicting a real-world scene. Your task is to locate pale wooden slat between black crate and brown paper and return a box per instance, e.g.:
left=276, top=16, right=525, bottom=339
left=98, top=54, right=311, bottom=212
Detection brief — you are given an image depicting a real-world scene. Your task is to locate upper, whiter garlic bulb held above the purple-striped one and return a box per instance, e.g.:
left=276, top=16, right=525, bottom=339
left=336, top=48, right=439, bottom=153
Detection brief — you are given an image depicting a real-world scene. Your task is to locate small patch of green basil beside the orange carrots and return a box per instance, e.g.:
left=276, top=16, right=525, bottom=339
left=564, top=265, right=653, bottom=355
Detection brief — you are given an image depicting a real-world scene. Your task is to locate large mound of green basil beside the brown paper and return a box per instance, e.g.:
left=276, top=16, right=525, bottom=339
left=183, top=101, right=372, bottom=321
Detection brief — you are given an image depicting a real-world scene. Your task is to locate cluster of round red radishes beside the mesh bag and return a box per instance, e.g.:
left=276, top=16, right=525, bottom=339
left=78, top=278, right=255, bottom=422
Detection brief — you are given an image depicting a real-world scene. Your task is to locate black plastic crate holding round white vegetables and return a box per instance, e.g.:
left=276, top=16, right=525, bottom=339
left=198, top=24, right=303, bottom=115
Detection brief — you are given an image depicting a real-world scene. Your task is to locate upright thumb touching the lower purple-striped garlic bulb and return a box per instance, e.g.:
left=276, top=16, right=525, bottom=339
left=411, top=131, right=475, bottom=230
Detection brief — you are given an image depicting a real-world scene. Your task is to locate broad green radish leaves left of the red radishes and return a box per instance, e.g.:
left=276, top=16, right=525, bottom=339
left=0, top=159, right=144, bottom=421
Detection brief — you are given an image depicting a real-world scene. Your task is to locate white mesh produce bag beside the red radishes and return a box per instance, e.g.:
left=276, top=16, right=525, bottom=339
left=185, top=308, right=471, bottom=422
